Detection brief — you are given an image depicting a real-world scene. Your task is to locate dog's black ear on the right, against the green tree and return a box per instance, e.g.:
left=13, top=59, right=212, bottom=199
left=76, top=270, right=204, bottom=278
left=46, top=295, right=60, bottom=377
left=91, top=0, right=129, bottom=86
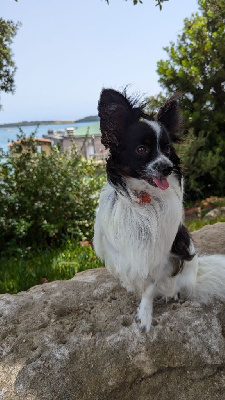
left=157, top=96, right=181, bottom=142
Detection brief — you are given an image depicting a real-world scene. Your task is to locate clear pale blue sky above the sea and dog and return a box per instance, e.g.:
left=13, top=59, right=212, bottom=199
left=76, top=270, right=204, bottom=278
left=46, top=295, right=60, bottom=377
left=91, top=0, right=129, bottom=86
left=0, top=0, right=198, bottom=124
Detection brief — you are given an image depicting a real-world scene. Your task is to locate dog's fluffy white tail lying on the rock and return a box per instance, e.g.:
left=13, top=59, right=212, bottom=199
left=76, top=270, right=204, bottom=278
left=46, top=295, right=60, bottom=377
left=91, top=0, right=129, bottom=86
left=190, top=255, right=225, bottom=303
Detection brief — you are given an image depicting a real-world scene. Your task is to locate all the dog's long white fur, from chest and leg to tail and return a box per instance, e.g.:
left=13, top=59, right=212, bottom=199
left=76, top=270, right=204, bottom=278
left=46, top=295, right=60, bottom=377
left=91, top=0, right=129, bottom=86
left=94, top=122, right=225, bottom=331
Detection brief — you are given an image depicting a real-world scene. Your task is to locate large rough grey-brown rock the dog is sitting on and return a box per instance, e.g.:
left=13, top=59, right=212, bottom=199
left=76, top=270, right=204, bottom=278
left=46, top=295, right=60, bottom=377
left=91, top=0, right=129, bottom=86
left=0, top=223, right=225, bottom=400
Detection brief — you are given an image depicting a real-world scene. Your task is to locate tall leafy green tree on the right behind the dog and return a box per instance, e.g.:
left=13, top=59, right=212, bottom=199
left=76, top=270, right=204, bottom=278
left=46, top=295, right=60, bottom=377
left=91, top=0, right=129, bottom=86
left=157, top=0, right=225, bottom=197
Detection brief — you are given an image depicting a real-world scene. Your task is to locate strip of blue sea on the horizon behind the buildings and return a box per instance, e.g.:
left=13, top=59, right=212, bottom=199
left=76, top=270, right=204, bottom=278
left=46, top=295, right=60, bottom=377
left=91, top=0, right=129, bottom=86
left=0, top=121, right=96, bottom=152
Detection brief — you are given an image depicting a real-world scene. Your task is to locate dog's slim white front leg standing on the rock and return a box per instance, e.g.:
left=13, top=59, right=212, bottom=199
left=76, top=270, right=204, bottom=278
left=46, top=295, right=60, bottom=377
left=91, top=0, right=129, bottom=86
left=136, top=283, right=155, bottom=332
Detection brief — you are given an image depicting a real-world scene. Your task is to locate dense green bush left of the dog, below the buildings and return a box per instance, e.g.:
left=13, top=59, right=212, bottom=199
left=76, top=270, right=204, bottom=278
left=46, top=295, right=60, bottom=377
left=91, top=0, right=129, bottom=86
left=0, top=135, right=104, bottom=253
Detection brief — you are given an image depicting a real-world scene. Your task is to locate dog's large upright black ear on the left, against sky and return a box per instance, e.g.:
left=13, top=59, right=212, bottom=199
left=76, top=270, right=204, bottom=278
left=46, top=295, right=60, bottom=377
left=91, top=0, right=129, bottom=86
left=98, top=89, right=134, bottom=148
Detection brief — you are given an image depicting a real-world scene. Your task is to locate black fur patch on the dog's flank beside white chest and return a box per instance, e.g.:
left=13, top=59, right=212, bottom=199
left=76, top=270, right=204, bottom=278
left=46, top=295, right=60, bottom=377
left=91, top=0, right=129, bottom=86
left=171, top=224, right=195, bottom=276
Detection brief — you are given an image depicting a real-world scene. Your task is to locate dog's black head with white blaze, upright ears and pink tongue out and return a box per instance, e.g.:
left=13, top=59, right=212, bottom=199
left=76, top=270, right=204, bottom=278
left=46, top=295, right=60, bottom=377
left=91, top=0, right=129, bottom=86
left=98, top=89, right=180, bottom=190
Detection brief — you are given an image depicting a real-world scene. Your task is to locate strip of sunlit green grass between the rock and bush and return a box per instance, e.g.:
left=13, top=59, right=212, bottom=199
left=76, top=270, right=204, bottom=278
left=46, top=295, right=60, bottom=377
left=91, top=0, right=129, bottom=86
left=0, top=240, right=102, bottom=293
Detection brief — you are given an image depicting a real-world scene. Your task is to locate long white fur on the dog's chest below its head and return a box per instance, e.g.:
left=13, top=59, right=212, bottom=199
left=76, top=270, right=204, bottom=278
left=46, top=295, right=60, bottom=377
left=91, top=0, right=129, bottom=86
left=94, top=175, right=183, bottom=292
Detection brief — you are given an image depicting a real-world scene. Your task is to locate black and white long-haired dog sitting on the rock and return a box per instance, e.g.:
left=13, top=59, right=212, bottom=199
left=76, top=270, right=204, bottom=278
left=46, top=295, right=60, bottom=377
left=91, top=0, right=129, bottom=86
left=94, top=89, right=225, bottom=331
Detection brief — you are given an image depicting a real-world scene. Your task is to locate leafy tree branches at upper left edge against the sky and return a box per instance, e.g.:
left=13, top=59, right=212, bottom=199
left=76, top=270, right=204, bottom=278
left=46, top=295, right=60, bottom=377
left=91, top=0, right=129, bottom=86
left=0, top=18, right=21, bottom=109
